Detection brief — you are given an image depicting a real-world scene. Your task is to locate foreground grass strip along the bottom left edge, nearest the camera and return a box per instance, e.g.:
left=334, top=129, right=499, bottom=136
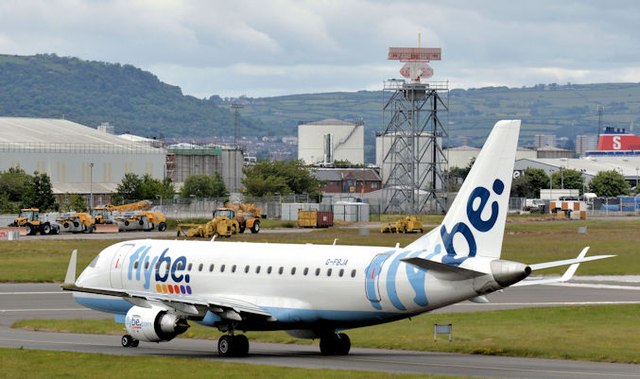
left=0, top=349, right=451, bottom=379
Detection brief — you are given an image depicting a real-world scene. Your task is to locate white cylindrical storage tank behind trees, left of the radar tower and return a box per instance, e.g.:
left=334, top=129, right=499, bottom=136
left=298, top=119, right=364, bottom=165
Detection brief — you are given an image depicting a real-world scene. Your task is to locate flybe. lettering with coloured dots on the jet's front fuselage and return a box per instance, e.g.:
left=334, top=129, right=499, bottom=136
left=127, top=246, right=191, bottom=295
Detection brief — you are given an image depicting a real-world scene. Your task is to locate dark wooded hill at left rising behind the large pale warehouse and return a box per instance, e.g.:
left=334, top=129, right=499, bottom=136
left=0, top=55, right=264, bottom=138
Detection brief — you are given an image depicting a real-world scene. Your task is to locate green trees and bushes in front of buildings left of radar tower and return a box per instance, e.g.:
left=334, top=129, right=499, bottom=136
left=0, top=160, right=322, bottom=213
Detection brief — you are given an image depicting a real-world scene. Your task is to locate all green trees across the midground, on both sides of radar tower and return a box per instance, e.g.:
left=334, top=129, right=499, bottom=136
left=0, top=160, right=637, bottom=213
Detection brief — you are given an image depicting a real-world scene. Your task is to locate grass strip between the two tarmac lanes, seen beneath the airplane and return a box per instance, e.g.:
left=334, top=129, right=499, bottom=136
left=14, top=305, right=640, bottom=364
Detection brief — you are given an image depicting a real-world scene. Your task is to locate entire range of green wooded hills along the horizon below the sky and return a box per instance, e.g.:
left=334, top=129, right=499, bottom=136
left=0, top=55, right=640, bottom=161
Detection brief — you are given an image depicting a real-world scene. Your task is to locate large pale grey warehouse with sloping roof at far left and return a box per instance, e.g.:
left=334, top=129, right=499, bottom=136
left=0, top=117, right=166, bottom=204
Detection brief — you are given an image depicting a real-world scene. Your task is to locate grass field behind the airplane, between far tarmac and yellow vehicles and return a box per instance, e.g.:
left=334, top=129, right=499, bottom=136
left=0, top=217, right=640, bottom=282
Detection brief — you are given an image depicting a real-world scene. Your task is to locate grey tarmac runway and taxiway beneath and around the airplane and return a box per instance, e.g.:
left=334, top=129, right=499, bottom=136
left=0, top=276, right=640, bottom=378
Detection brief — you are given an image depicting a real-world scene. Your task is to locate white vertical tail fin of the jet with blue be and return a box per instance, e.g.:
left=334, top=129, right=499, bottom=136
left=407, top=120, right=520, bottom=264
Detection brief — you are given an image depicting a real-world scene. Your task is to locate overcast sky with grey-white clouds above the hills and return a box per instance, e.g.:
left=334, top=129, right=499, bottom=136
left=0, top=0, right=640, bottom=98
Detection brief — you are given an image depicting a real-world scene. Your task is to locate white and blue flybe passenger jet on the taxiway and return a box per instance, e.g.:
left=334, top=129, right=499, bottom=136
left=62, top=120, right=613, bottom=357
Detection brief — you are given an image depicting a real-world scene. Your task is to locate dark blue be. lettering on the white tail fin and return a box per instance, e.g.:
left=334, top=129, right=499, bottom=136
left=440, top=179, right=504, bottom=265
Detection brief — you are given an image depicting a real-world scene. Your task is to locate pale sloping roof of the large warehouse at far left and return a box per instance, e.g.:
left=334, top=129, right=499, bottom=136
left=0, top=117, right=158, bottom=152
